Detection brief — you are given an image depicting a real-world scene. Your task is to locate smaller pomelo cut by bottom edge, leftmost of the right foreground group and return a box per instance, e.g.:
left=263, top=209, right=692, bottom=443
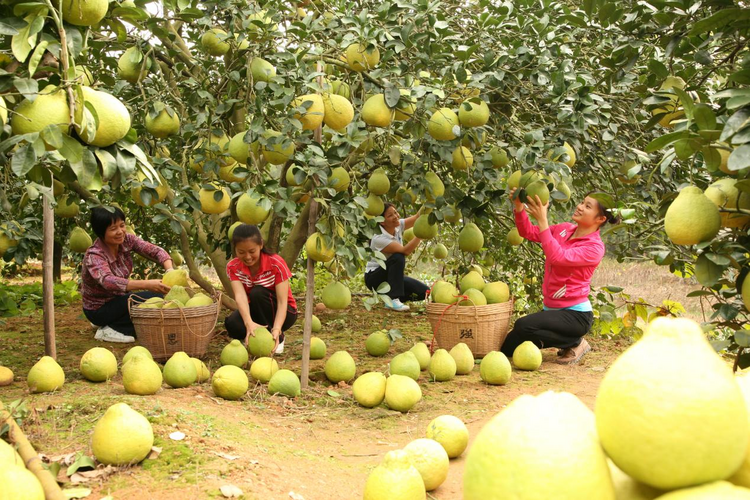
left=364, top=450, right=426, bottom=500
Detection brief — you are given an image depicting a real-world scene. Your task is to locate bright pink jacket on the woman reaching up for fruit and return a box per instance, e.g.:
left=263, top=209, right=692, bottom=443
left=514, top=210, right=604, bottom=309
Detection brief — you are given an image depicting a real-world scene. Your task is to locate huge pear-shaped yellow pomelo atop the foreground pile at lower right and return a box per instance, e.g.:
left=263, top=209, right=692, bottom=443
left=596, top=318, right=750, bottom=489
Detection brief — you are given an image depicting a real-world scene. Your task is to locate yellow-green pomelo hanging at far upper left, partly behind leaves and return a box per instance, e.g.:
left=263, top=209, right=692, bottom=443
left=10, top=85, right=70, bottom=139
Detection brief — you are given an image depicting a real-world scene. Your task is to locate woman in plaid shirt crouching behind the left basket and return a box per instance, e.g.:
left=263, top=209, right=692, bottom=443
left=81, top=207, right=172, bottom=342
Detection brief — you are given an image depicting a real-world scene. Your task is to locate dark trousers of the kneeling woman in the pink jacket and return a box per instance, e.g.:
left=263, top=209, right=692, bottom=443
left=500, top=309, right=594, bottom=357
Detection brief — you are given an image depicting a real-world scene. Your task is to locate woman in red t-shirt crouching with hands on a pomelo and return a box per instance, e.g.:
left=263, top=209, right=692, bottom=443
left=224, top=224, right=297, bottom=354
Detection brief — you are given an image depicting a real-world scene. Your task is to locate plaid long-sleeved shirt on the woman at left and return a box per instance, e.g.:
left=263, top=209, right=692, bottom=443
left=81, top=234, right=171, bottom=311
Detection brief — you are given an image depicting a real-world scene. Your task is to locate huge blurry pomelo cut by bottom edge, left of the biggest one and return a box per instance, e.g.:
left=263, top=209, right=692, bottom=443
left=464, top=391, right=615, bottom=500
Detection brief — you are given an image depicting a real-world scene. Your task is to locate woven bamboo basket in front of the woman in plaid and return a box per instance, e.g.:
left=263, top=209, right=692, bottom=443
left=128, top=291, right=221, bottom=361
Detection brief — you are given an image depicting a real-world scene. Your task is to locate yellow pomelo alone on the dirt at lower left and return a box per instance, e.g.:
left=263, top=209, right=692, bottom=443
left=91, top=403, right=154, bottom=465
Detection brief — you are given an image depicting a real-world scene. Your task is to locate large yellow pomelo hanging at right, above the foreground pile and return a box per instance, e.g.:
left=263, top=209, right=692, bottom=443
left=664, top=186, right=721, bottom=245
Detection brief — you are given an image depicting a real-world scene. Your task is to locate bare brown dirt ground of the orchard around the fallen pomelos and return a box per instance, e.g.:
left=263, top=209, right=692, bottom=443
left=0, top=299, right=630, bottom=500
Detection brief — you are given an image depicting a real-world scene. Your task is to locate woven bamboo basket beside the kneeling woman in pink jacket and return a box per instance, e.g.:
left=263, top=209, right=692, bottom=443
left=427, top=298, right=513, bottom=358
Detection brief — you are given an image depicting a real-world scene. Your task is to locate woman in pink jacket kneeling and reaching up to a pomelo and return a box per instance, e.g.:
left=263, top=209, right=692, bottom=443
left=501, top=189, right=619, bottom=364
